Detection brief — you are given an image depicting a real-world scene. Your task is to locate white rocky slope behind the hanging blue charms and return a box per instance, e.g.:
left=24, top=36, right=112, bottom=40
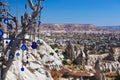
left=2, top=35, right=62, bottom=80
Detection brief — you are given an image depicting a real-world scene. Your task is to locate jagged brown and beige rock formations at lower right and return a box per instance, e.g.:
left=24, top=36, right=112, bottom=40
left=66, top=42, right=120, bottom=80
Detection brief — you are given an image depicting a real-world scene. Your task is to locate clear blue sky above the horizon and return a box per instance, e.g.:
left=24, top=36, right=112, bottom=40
left=4, top=0, right=120, bottom=26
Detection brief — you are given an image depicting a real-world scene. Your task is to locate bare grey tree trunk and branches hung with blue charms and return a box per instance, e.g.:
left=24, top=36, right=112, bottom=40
left=0, top=0, right=42, bottom=80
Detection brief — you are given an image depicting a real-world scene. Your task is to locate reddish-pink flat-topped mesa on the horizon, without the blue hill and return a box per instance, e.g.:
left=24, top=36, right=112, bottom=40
left=42, top=24, right=104, bottom=32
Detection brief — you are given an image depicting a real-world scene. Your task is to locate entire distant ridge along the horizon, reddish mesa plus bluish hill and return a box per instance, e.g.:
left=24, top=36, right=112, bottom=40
left=42, top=23, right=120, bottom=32
